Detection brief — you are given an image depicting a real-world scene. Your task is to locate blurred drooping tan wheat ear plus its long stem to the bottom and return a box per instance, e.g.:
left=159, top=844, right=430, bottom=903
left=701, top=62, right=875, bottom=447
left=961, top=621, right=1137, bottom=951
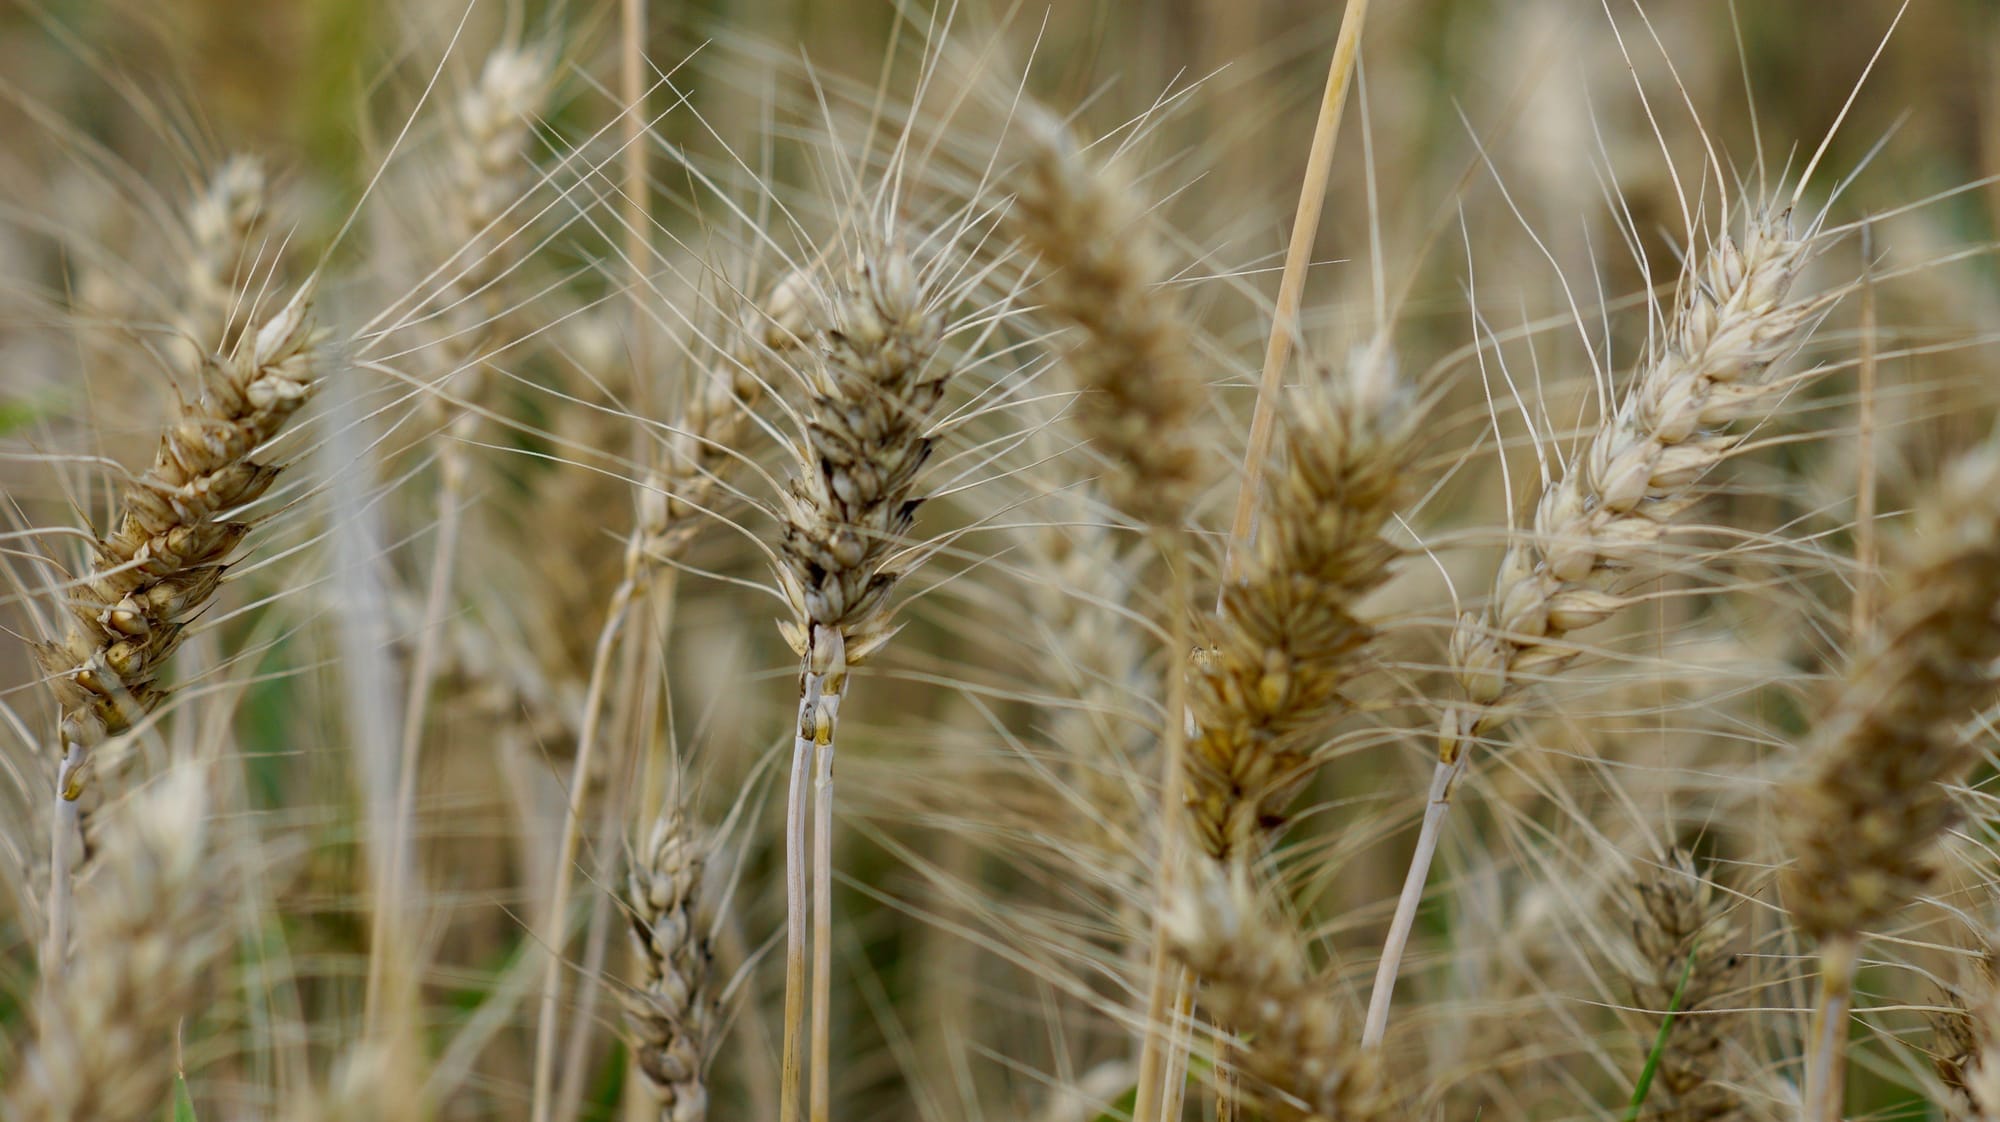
left=1008, top=108, right=1208, bottom=1122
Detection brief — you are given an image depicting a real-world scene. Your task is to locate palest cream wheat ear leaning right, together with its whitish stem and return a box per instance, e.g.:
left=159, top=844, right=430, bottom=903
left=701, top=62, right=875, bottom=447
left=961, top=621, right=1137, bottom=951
left=1366, top=210, right=1822, bottom=1046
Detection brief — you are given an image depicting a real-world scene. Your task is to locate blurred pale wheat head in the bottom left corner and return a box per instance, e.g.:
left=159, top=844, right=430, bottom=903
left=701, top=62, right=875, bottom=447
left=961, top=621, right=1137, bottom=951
left=6, top=768, right=238, bottom=1122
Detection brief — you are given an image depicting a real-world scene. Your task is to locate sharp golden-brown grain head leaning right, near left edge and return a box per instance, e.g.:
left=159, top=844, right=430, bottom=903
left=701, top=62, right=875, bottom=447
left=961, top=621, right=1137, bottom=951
left=38, top=286, right=314, bottom=756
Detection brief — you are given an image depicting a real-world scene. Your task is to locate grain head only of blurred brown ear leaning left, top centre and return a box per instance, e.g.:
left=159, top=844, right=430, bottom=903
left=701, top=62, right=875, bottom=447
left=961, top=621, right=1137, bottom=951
left=1008, top=110, right=1206, bottom=526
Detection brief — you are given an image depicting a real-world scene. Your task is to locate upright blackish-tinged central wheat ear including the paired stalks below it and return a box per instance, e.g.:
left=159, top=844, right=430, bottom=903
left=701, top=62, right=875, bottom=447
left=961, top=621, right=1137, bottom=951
left=776, top=246, right=952, bottom=1122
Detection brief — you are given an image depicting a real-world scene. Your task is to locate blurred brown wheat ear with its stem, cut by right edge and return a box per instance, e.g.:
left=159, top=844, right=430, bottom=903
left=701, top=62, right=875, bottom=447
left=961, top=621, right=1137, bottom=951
left=1778, top=444, right=2000, bottom=1122
